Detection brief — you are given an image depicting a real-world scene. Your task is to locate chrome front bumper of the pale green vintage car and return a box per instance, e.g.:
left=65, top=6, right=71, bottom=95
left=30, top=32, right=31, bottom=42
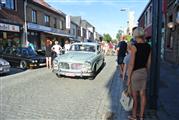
left=52, top=69, right=94, bottom=77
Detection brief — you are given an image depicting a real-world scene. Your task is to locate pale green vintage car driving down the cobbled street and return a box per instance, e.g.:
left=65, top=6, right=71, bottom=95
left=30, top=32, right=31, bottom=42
left=53, top=43, right=104, bottom=80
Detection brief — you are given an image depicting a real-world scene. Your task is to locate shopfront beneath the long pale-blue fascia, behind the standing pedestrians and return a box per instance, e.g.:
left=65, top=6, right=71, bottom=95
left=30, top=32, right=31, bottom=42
left=28, top=23, right=69, bottom=50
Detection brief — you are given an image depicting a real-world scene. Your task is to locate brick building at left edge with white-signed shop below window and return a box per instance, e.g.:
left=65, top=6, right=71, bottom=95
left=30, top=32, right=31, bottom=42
left=0, top=0, right=24, bottom=51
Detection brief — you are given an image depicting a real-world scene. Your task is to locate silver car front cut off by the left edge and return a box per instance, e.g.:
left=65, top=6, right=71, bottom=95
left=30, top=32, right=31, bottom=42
left=0, top=58, right=11, bottom=74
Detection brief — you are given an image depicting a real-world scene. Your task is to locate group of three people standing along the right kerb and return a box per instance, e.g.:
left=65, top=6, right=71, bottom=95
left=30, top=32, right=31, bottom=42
left=116, top=27, right=151, bottom=120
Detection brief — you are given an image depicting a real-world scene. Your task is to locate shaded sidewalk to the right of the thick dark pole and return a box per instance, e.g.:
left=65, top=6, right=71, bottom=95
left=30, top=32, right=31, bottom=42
left=157, top=62, right=179, bottom=120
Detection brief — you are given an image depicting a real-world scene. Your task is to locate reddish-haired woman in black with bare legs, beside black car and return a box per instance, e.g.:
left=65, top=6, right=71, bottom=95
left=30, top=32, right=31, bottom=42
left=45, top=38, right=52, bottom=69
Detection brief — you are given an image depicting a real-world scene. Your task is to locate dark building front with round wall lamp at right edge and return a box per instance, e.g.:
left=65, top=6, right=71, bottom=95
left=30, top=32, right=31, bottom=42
left=164, top=0, right=179, bottom=64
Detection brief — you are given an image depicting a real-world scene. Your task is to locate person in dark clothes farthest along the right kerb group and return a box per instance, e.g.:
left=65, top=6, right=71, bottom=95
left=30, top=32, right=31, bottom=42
left=116, top=37, right=127, bottom=78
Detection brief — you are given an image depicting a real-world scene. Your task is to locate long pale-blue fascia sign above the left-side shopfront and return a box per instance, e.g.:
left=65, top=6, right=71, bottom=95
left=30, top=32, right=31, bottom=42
left=28, top=23, right=66, bottom=34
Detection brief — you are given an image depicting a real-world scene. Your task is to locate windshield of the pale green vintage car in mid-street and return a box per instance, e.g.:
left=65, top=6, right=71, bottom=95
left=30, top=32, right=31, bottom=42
left=70, top=44, right=96, bottom=52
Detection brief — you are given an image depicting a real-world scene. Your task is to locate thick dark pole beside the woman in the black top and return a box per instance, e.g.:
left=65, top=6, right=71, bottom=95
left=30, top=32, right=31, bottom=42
left=148, top=0, right=162, bottom=110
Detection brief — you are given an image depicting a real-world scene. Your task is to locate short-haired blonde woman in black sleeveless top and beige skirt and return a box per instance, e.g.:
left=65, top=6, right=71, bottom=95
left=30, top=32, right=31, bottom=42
left=127, top=27, right=151, bottom=120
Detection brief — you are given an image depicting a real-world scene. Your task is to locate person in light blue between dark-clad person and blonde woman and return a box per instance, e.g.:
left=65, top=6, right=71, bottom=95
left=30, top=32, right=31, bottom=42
left=122, top=42, right=131, bottom=80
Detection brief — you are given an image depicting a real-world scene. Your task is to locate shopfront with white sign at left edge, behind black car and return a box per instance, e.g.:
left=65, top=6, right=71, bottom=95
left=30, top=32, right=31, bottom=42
left=0, top=23, right=22, bottom=51
